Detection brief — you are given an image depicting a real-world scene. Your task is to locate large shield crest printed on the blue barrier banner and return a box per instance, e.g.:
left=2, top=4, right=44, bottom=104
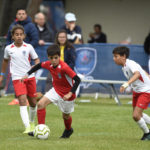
left=75, top=47, right=97, bottom=75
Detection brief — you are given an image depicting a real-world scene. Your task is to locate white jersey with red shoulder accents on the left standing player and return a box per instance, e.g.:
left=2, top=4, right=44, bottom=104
left=4, top=42, right=38, bottom=80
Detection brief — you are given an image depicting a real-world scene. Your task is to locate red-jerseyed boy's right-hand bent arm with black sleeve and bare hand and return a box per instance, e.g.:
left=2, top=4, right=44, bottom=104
left=63, top=75, right=81, bottom=100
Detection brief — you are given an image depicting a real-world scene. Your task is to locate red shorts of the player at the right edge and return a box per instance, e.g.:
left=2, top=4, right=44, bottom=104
left=132, top=91, right=150, bottom=109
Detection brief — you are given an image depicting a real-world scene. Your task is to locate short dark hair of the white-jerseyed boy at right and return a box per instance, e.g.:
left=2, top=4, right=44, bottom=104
left=113, top=46, right=130, bottom=58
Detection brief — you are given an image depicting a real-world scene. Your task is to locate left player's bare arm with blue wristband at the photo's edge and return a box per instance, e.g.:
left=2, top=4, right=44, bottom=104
left=0, top=59, right=9, bottom=85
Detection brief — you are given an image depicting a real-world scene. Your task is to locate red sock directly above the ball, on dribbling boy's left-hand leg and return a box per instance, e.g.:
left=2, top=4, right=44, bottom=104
left=37, top=108, right=46, bottom=124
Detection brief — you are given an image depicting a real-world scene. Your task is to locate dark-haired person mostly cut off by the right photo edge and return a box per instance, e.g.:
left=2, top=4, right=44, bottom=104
left=144, top=33, right=150, bottom=73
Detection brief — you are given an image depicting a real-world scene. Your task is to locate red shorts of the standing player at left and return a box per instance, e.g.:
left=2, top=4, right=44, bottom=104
left=13, top=77, right=36, bottom=97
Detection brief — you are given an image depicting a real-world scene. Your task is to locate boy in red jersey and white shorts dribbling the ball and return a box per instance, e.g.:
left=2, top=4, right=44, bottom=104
left=25, top=44, right=80, bottom=138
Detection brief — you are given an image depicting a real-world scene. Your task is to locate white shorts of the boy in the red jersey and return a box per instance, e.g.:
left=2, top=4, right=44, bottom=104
left=44, top=88, right=74, bottom=114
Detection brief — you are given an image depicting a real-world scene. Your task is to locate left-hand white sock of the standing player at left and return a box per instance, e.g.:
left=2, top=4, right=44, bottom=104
left=20, top=106, right=29, bottom=128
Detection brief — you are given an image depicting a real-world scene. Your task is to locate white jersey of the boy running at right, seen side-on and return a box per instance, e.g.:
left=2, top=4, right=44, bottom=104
left=122, top=59, right=150, bottom=93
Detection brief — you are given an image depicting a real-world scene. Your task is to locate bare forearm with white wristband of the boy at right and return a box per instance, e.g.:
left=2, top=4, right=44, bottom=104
left=120, top=71, right=140, bottom=93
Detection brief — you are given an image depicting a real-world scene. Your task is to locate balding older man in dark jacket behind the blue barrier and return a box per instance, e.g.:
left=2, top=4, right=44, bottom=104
left=34, top=12, right=53, bottom=45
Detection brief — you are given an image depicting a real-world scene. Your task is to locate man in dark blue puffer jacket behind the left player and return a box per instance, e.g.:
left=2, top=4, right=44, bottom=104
left=6, top=9, right=38, bottom=47
